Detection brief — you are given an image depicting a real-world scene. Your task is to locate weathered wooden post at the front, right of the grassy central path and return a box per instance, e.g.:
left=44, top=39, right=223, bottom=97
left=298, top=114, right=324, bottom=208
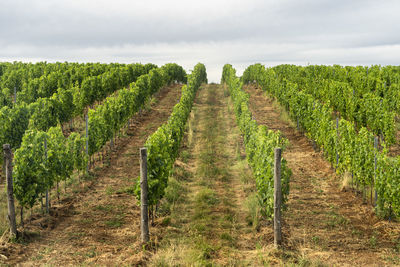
left=274, top=147, right=282, bottom=248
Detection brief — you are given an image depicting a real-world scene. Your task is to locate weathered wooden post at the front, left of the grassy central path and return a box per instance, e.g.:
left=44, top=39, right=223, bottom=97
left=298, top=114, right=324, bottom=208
left=140, top=148, right=150, bottom=244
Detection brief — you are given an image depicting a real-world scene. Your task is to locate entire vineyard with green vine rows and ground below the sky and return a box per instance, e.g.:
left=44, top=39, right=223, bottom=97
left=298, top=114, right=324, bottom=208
left=0, top=62, right=400, bottom=266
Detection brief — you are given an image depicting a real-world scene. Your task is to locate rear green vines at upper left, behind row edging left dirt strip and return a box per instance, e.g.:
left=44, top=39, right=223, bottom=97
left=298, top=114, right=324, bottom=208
left=0, top=63, right=152, bottom=157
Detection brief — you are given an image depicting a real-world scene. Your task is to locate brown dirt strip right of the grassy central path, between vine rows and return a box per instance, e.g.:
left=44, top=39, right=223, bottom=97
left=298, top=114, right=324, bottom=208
left=246, top=86, right=400, bottom=266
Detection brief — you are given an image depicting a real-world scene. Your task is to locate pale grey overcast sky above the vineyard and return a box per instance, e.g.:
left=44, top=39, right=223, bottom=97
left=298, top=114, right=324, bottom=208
left=0, top=0, right=400, bottom=82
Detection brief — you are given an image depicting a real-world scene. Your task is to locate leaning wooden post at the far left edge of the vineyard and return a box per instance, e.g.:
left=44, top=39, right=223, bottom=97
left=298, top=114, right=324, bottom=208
left=3, top=144, right=18, bottom=238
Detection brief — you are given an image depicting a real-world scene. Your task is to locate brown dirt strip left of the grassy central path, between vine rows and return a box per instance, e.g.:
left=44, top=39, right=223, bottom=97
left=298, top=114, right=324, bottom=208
left=6, top=85, right=181, bottom=266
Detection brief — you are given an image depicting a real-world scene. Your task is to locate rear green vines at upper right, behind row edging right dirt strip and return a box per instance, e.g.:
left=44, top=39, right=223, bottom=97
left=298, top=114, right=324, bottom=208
left=250, top=64, right=400, bottom=144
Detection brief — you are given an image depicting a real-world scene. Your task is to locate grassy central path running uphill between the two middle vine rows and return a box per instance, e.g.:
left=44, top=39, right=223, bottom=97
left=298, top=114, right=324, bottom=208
left=149, top=85, right=265, bottom=266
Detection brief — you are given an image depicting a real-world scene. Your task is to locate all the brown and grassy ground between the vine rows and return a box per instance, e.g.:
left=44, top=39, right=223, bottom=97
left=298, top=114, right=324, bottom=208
left=0, top=84, right=400, bottom=266
